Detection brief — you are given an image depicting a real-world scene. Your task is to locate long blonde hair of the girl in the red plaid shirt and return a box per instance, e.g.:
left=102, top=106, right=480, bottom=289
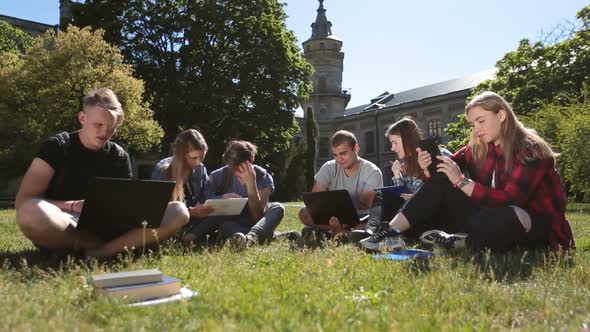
left=465, top=91, right=558, bottom=170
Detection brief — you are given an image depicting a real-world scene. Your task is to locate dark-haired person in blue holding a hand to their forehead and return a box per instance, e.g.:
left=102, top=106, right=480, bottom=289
left=183, top=140, right=285, bottom=248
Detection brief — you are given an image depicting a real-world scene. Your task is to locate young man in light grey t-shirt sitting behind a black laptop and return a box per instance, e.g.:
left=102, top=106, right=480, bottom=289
left=299, top=130, right=383, bottom=234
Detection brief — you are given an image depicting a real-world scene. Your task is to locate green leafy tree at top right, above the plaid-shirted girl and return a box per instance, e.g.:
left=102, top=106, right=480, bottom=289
left=474, top=6, right=590, bottom=114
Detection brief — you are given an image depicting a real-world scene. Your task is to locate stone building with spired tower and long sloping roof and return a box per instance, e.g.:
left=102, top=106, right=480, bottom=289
left=299, top=0, right=495, bottom=183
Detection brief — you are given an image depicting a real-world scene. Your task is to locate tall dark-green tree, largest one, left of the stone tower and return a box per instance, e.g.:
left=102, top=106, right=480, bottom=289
left=73, top=0, right=312, bottom=173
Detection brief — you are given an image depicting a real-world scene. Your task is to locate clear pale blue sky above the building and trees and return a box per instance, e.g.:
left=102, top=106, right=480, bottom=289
left=0, top=0, right=589, bottom=107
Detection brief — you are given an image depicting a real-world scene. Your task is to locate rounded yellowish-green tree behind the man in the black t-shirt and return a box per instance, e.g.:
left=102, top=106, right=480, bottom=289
left=0, top=27, right=163, bottom=179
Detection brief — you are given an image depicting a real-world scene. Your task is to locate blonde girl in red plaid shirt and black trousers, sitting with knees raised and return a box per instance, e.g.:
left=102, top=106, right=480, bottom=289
left=361, top=92, right=575, bottom=251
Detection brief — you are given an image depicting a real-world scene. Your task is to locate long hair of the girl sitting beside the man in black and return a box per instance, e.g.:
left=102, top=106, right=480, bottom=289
left=163, top=129, right=208, bottom=201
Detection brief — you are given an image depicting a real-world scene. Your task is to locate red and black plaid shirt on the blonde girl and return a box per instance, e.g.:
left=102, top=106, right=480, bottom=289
left=451, top=144, right=575, bottom=250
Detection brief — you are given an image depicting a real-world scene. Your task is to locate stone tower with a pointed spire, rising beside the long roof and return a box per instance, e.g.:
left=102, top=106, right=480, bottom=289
left=302, top=0, right=350, bottom=122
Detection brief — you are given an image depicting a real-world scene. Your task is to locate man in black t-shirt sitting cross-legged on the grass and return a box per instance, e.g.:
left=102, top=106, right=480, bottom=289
left=16, top=88, right=188, bottom=257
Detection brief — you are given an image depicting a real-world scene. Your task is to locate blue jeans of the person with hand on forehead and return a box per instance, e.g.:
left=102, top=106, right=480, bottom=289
left=188, top=202, right=285, bottom=243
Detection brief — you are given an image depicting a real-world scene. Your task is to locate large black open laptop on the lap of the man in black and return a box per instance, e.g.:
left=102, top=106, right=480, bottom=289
left=76, top=178, right=174, bottom=241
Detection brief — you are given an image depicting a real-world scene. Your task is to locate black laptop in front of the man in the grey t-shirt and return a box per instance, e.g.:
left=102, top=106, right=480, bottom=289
left=303, top=190, right=368, bottom=227
